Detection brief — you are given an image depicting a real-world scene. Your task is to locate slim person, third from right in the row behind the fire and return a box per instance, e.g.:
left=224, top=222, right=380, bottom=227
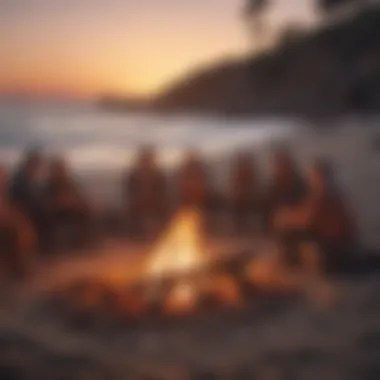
left=229, top=153, right=259, bottom=233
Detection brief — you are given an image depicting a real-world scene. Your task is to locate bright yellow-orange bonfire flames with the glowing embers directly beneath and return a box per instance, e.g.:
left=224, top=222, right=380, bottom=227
left=146, top=208, right=239, bottom=314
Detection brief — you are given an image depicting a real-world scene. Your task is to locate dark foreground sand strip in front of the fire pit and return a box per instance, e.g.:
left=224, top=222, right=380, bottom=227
left=0, top=277, right=380, bottom=380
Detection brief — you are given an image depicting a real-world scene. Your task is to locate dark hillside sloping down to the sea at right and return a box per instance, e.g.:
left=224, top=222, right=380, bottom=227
left=154, top=9, right=380, bottom=115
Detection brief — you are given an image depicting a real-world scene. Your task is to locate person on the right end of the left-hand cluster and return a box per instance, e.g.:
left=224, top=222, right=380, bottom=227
left=45, top=158, right=93, bottom=248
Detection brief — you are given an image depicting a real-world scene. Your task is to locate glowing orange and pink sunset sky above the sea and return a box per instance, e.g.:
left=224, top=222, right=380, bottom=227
left=0, top=0, right=315, bottom=97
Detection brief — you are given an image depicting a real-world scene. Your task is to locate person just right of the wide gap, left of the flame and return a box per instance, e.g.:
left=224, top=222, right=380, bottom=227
left=123, top=148, right=169, bottom=237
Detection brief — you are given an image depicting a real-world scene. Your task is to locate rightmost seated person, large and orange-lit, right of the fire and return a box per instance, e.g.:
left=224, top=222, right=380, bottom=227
left=275, top=162, right=357, bottom=270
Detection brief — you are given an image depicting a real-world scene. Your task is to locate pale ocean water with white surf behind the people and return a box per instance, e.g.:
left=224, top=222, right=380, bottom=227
left=0, top=102, right=296, bottom=204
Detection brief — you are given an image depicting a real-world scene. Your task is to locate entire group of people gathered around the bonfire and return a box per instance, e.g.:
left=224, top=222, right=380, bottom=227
left=0, top=148, right=357, bottom=275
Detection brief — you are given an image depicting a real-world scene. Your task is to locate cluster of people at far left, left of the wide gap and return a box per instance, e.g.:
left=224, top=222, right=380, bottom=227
left=0, top=151, right=91, bottom=276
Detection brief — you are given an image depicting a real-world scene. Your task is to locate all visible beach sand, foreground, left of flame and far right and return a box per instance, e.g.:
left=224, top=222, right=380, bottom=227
left=0, top=119, right=380, bottom=380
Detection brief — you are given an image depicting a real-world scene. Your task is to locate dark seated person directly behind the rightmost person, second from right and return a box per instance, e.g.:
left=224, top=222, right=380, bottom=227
left=262, top=151, right=306, bottom=232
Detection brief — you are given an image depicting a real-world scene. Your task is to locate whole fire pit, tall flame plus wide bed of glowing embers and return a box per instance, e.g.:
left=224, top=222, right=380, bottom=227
left=37, top=209, right=312, bottom=332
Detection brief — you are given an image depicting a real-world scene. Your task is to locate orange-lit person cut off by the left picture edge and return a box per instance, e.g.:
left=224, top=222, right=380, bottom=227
left=0, top=167, right=37, bottom=278
